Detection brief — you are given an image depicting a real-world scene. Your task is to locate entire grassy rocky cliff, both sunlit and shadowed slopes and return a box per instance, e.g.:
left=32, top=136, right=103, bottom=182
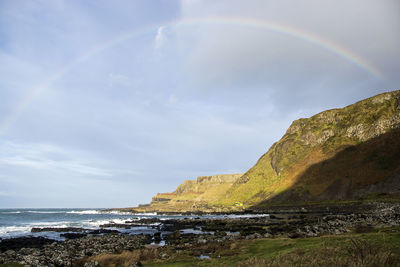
left=136, top=91, right=400, bottom=214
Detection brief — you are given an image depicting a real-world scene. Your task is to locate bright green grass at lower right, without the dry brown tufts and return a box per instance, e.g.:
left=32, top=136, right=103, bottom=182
left=145, top=227, right=400, bottom=266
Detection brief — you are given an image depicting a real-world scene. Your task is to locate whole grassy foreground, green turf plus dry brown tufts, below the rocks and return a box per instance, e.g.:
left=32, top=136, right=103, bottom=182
left=0, top=231, right=400, bottom=267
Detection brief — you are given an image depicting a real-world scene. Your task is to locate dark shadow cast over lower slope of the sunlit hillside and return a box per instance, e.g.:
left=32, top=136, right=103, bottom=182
left=250, top=129, right=400, bottom=210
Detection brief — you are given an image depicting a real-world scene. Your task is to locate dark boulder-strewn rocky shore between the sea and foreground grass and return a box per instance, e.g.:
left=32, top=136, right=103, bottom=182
left=0, top=203, right=400, bottom=266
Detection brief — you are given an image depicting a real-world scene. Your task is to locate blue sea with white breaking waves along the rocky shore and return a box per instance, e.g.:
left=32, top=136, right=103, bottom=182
left=0, top=208, right=267, bottom=241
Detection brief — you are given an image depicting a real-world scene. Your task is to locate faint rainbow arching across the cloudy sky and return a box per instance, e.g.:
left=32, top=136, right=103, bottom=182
left=0, top=17, right=383, bottom=134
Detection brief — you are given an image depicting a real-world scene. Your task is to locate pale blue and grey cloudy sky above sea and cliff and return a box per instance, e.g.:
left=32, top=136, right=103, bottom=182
left=0, top=0, right=400, bottom=208
